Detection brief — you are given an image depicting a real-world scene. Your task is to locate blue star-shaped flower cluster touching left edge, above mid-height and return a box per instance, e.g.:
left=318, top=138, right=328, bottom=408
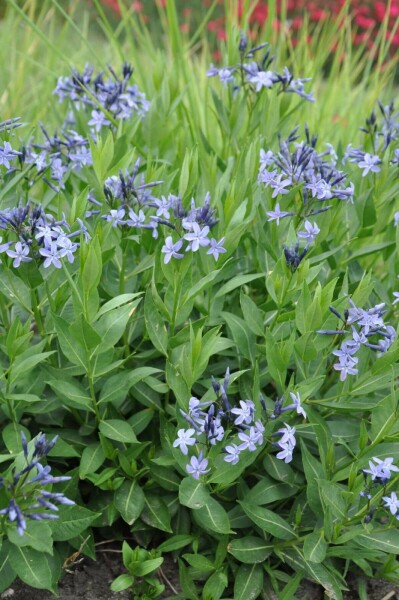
left=0, top=203, right=90, bottom=269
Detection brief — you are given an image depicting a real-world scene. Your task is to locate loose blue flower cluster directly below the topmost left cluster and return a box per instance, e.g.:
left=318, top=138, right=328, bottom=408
left=19, top=125, right=93, bottom=192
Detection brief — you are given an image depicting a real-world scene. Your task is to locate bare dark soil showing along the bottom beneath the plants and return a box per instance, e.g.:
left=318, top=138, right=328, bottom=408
left=0, top=550, right=399, bottom=600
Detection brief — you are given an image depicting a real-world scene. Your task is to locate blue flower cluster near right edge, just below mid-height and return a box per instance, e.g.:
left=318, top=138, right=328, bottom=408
left=318, top=300, right=396, bottom=381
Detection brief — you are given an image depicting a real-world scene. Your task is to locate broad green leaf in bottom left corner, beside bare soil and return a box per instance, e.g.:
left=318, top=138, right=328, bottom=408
left=9, top=544, right=55, bottom=591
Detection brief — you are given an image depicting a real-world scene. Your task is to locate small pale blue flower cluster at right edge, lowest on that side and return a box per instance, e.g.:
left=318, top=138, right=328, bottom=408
left=360, top=456, right=399, bottom=523
